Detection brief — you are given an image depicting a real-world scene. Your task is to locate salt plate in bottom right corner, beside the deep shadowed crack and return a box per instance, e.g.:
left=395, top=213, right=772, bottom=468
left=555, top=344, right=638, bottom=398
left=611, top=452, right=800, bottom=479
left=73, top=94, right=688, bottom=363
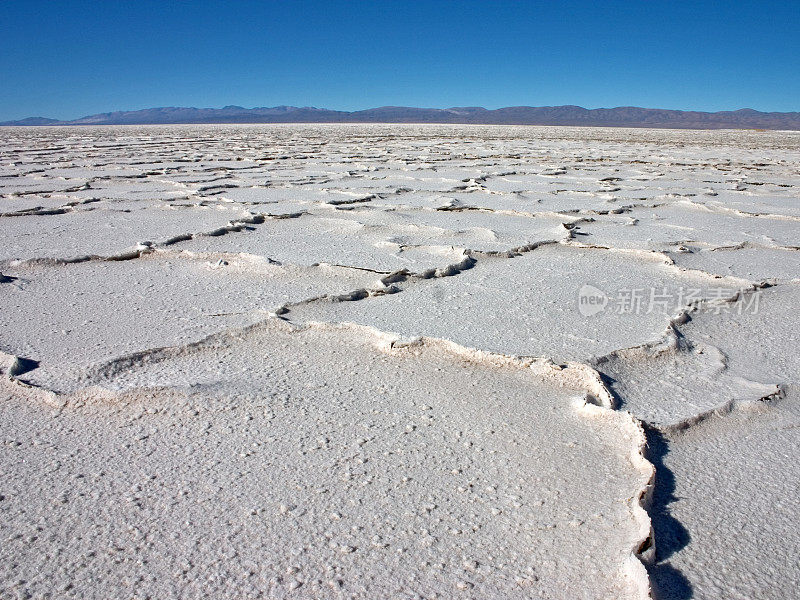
left=652, top=388, right=800, bottom=600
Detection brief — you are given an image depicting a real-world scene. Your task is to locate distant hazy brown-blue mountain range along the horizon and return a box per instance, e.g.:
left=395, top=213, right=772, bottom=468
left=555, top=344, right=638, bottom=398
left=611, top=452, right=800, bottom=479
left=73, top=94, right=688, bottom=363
left=0, top=106, right=800, bottom=130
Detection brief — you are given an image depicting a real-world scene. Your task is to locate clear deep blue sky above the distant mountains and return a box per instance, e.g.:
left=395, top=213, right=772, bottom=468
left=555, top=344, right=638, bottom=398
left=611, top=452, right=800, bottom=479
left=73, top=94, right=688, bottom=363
left=0, top=0, right=800, bottom=120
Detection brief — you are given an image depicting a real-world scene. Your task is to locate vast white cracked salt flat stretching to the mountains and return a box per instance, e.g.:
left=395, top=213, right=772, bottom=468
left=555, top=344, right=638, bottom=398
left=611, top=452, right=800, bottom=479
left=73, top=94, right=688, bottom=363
left=0, top=125, right=800, bottom=599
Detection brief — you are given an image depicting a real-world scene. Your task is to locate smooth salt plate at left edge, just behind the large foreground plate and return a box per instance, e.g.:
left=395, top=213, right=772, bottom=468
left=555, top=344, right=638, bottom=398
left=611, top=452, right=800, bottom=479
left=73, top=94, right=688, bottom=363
left=0, top=253, right=377, bottom=390
